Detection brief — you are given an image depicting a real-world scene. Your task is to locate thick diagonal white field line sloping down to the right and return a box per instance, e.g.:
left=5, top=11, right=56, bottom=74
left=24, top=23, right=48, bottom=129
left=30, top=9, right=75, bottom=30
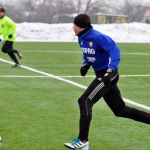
left=0, top=58, right=150, bottom=110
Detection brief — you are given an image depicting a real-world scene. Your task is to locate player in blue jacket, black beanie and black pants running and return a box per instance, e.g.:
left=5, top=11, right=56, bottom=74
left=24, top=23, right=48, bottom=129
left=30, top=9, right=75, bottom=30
left=64, top=14, right=150, bottom=150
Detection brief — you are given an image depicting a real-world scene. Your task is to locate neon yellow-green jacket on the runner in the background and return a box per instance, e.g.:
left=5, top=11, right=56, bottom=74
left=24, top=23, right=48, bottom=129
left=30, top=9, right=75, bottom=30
left=0, top=16, right=16, bottom=42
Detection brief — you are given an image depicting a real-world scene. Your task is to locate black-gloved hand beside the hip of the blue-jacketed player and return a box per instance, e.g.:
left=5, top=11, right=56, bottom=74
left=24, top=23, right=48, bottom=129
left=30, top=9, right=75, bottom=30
left=102, top=69, right=118, bottom=85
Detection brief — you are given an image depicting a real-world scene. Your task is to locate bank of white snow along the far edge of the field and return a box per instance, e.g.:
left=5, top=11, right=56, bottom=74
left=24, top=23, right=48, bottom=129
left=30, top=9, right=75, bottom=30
left=16, top=23, right=150, bottom=43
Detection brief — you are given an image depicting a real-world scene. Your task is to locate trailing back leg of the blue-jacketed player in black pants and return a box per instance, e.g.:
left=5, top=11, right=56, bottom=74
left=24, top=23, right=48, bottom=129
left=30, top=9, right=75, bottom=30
left=104, top=85, right=150, bottom=124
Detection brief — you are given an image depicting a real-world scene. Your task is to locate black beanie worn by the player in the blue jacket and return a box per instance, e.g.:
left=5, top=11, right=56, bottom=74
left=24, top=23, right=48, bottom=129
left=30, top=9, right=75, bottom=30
left=74, top=14, right=91, bottom=28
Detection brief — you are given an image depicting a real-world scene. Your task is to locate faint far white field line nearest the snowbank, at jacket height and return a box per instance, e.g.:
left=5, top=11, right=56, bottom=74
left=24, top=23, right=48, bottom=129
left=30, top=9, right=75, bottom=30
left=23, top=50, right=150, bottom=56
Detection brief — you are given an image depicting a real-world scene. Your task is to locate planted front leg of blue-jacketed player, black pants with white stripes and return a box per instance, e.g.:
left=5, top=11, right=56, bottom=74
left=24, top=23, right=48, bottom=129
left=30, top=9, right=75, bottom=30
left=78, top=79, right=109, bottom=141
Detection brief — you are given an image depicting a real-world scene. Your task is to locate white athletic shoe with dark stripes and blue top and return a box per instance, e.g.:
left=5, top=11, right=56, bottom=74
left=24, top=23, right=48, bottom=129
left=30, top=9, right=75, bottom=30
left=64, top=139, right=89, bottom=150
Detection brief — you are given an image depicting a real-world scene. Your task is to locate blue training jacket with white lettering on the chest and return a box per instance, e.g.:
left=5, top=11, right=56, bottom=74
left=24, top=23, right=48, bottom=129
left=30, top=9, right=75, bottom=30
left=78, top=26, right=120, bottom=71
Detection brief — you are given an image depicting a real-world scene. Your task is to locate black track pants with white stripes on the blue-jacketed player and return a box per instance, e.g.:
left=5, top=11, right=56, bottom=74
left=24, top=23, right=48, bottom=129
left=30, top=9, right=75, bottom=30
left=78, top=73, right=150, bottom=141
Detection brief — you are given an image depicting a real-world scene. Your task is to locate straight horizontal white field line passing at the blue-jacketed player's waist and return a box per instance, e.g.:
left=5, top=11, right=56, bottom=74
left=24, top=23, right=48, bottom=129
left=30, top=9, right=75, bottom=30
left=0, top=75, right=150, bottom=78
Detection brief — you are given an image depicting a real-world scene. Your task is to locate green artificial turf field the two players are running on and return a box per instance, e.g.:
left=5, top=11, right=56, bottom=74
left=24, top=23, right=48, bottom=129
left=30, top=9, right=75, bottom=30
left=0, top=42, right=150, bottom=150
